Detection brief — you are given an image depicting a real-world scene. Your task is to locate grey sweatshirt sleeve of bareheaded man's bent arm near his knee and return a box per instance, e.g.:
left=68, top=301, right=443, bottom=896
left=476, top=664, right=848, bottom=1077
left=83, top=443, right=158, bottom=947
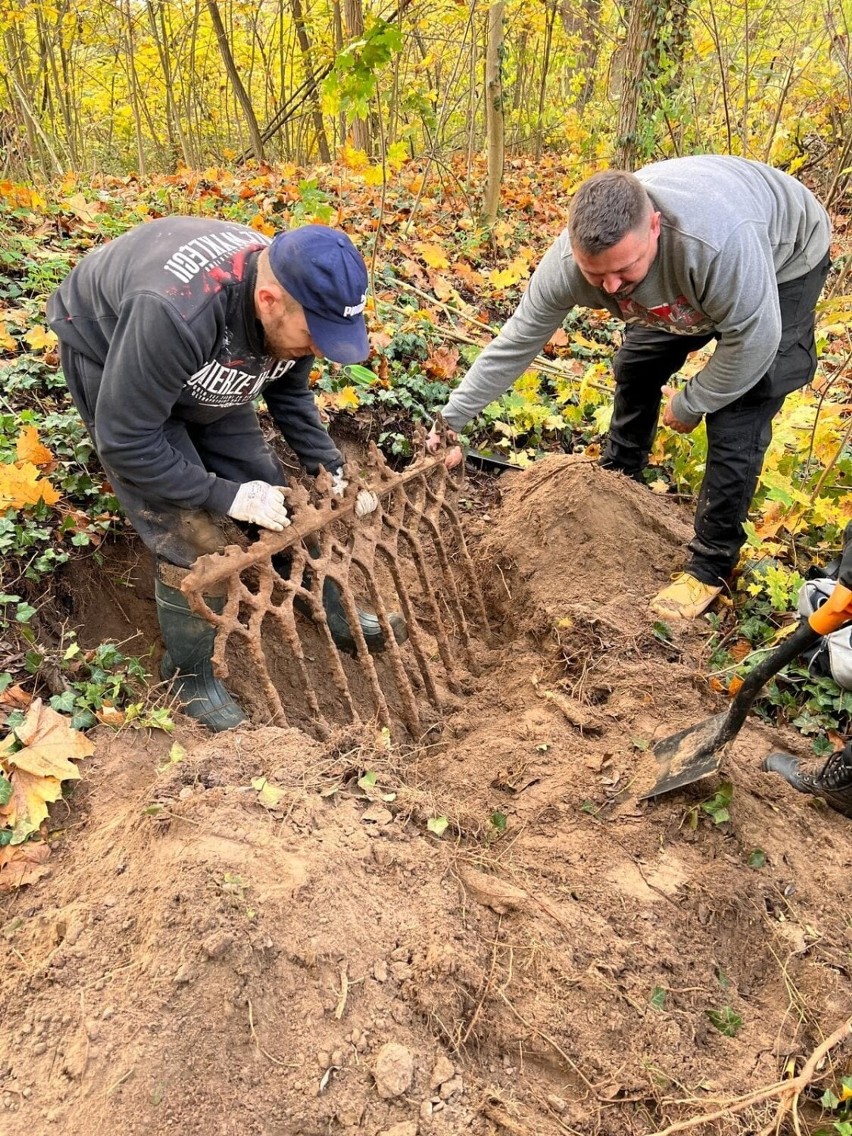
left=671, top=224, right=782, bottom=426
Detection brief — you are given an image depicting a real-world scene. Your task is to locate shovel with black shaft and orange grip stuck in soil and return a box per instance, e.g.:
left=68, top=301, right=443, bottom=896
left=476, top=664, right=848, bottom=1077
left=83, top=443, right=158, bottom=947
left=638, top=584, right=852, bottom=801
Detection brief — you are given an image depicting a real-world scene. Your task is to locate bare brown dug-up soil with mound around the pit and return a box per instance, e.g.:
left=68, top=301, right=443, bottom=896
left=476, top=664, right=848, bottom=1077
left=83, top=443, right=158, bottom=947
left=0, top=458, right=852, bottom=1136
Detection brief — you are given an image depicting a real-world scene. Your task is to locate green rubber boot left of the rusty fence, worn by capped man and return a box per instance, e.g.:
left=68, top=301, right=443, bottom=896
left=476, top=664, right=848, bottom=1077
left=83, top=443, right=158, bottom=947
left=154, top=576, right=247, bottom=734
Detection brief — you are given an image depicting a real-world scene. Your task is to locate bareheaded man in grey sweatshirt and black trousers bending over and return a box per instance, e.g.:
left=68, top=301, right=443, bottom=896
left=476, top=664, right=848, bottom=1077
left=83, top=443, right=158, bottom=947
left=431, top=154, right=830, bottom=619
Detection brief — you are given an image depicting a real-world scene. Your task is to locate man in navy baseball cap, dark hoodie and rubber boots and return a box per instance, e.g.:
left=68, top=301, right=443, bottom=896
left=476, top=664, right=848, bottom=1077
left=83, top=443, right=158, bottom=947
left=48, top=217, right=406, bottom=730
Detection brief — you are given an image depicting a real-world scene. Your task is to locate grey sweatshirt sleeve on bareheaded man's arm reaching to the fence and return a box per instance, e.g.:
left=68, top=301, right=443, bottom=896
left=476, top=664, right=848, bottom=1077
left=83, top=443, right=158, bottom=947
left=441, top=234, right=576, bottom=431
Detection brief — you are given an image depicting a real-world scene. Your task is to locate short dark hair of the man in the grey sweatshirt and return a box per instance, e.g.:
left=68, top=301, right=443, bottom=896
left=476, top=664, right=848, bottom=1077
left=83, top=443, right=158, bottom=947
left=568, top=169, right=653, bottom=257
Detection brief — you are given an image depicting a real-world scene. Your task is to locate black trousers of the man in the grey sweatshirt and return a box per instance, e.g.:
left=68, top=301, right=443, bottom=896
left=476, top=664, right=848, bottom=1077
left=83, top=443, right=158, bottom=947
left=601, top=254, right=830, bottom=584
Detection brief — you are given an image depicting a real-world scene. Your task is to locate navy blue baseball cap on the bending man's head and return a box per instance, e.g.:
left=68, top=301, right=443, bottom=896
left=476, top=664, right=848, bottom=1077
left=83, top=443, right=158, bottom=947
left=269, top=225, right=370, bottom=362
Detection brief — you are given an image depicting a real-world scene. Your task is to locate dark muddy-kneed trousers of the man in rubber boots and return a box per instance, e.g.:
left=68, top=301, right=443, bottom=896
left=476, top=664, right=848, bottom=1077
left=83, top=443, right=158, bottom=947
left=59, top=344, right=286, bottom=568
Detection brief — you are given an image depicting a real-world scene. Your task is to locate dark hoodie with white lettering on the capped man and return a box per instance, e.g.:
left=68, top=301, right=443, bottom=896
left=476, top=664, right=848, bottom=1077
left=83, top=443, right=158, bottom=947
left=48, top=217, right=343, bottom=513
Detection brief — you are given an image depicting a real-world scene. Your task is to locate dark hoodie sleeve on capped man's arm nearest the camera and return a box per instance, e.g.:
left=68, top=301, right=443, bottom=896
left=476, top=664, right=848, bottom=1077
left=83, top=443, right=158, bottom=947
left=94, top=294, right=239, bottom=513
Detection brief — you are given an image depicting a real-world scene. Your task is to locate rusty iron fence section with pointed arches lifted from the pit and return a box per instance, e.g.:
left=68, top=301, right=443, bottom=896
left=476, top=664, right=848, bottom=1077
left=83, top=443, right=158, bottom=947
left=181, top=446, right=490, bottom=738
